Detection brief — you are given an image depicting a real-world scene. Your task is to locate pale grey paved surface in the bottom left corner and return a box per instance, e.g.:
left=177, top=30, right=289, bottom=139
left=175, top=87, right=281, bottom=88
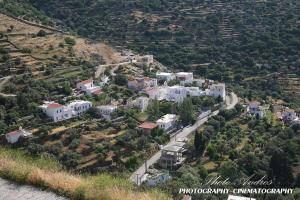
left=0, top=178, right=66, bottom=200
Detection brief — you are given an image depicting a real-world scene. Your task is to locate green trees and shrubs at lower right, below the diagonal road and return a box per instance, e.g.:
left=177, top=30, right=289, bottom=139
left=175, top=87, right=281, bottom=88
left=160, top=106, right=300, bottom=200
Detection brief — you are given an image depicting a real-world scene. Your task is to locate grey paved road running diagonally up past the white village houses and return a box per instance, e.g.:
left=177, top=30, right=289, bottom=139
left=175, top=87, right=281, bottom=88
left=130, top=93, right=238, bottom=183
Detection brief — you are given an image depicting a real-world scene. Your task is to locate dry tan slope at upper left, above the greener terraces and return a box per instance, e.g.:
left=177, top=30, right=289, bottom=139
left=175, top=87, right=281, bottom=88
left=0, top=14, right=120, bottom=78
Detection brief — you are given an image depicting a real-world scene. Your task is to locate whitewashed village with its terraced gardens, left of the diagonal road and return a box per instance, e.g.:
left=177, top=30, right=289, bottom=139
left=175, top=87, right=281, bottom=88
left=2, top=12, right=226, bottom=177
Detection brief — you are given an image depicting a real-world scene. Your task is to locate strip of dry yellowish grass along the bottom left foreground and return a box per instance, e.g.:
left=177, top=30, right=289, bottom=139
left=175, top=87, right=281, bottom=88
left=0, top=147, right=169, bottom=200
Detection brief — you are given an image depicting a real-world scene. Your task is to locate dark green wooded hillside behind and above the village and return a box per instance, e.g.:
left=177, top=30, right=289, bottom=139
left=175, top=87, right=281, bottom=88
left=5, top=0, right=300, bottom=101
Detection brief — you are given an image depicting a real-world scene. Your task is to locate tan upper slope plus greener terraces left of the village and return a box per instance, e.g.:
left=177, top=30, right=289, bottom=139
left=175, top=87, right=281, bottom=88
left=0, top=14, right=122, bottom=138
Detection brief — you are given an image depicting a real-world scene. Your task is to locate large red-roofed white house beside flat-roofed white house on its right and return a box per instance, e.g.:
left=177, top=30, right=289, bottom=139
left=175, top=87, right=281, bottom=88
left=39, top=101, right=66, bottom=122
